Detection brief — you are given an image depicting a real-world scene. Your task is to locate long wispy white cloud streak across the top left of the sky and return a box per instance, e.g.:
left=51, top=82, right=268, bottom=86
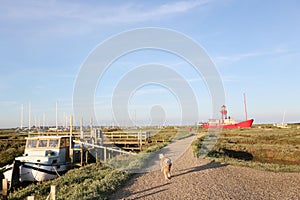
left=0, top=0, right=211, bottom=32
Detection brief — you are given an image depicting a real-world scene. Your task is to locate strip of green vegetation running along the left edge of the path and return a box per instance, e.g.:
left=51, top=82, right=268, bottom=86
left=2, top=127, right=190, bottom=200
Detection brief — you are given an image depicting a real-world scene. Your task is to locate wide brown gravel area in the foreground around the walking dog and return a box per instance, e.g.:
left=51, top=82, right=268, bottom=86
left=111, top=135, right=300, bottom=200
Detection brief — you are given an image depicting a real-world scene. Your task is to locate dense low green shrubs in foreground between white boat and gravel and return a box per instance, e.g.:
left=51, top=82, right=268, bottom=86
left=8, top=164, right=130, bottom=200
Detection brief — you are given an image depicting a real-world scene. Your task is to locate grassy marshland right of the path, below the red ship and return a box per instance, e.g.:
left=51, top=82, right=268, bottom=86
left=192, top=126, right=300, bottom=172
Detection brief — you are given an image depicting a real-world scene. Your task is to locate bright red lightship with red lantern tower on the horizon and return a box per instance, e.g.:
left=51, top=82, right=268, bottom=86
left=201, top=105, right=254, bottom=129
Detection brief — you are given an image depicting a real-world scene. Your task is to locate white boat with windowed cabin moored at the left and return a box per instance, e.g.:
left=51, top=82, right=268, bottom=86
left=2, top=136, right=76, bottom=187
